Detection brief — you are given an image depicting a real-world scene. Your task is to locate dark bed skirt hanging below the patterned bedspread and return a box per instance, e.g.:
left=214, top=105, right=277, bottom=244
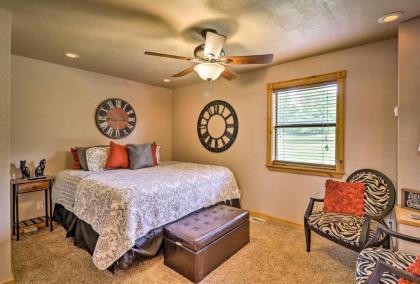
left=53, top=199, right=240, bottom=272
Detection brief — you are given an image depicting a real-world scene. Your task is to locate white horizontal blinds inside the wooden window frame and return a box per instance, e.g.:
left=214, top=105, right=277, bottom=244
left=272, top=82, right=337, bottom=167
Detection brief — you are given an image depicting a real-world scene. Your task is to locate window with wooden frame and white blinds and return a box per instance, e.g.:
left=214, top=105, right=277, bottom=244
left=267, top=71, right=346, bottom=177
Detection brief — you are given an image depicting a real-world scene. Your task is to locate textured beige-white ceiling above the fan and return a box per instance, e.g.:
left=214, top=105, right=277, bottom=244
left=0, top=0, right=420, bottom=88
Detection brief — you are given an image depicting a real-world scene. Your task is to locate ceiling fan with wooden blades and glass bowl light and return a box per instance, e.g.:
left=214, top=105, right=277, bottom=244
left=144, top=29, right=273, bottom=81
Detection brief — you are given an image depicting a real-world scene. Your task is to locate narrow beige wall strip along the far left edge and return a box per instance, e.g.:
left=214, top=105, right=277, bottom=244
left=0, top=9, right=13, bottom=283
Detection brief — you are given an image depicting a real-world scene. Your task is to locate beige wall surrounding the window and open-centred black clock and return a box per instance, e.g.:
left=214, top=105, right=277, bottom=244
left=172, top=39, right=397, bottom=223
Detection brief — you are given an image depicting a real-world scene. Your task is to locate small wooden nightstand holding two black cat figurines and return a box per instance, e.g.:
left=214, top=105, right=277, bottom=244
left=10, top=176, right=53, bottom=241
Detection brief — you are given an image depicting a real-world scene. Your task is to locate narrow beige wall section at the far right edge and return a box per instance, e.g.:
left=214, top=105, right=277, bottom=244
left=398, top=18, right=420, bottom=203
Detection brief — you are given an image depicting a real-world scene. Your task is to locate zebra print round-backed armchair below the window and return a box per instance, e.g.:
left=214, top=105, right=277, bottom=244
left=304, top=169, right=395, bottom=252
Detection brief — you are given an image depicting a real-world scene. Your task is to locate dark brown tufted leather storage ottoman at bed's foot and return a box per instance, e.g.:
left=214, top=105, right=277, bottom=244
left=164, top=205, right=249, bottom=283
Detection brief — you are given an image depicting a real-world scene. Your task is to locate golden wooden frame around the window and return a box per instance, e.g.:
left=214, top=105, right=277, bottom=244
left=266, top=70, right=346, bottom=178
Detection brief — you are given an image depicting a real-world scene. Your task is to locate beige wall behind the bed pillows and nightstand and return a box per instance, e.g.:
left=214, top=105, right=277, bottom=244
left=11, top=56, right=172, bottom=218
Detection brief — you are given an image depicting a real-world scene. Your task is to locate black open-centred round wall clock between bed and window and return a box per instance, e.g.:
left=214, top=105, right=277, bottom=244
left=197, top=100, right=239, bottom=152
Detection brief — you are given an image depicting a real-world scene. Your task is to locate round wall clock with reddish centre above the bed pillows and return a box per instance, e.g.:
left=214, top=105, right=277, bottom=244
left=95, top=98, right=137, bottom=139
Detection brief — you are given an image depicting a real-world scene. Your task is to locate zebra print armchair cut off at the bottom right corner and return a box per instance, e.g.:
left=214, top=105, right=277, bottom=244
left=356, top=227, right=420, bottom=284
